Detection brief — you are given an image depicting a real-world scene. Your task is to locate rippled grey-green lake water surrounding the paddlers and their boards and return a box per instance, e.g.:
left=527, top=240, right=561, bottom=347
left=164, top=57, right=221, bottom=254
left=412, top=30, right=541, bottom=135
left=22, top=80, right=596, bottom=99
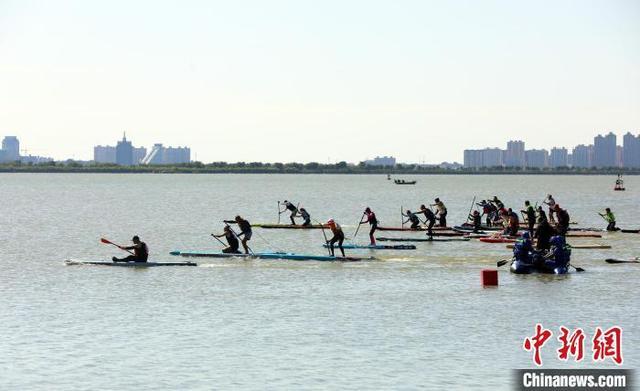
left=0, top=174, right=640, bottom=390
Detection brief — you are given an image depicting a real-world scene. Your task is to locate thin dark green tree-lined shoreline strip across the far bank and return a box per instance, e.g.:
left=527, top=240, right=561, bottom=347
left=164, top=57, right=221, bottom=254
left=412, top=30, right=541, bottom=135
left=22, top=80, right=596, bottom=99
left=0, top=162, right=640, bottom=176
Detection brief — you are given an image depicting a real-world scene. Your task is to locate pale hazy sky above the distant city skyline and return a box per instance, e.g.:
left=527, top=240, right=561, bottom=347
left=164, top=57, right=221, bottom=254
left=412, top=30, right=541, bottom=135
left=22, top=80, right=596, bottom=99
left=0, top=0, right=640, bottom=162
